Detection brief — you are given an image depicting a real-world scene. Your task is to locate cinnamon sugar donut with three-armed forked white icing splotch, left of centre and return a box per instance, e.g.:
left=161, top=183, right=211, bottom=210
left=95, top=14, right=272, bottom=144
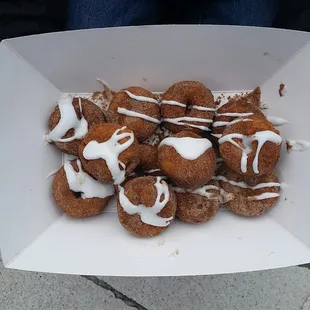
left=79, top=123, right=139, bottom=184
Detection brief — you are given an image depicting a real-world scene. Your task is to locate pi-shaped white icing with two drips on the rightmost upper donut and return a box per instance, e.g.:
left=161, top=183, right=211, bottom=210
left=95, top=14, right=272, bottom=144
left=218, top=130, right=282, bottom=174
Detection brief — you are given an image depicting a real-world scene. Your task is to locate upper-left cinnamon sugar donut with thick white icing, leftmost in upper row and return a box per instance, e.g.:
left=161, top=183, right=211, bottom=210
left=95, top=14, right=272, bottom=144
left=47, top=95, right=105, bottom=156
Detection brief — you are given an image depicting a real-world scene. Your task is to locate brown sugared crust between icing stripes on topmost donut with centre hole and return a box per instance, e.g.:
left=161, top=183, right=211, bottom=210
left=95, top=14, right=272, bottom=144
left=161, top=81, right=215, bottom=134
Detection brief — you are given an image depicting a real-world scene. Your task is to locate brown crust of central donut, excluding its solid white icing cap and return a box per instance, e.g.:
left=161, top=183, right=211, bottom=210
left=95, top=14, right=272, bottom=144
left=158, top=131, right=216, bottom=189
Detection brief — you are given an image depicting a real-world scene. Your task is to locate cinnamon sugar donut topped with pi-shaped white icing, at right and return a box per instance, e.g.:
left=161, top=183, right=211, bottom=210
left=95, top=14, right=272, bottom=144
left=219, top=117, right=282, bottom=176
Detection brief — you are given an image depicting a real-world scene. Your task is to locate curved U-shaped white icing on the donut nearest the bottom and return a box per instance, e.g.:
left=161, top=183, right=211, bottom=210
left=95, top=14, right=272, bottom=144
left=119, top=177, right=173, bottom=227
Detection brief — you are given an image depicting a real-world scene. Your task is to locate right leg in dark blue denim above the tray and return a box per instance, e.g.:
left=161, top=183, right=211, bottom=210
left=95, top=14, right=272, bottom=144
left=179, top=0, right=279, bottom=27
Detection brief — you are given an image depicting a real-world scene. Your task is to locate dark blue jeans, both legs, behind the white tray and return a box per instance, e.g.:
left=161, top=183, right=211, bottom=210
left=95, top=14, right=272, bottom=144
left=68, top=0, right=279, bottom=29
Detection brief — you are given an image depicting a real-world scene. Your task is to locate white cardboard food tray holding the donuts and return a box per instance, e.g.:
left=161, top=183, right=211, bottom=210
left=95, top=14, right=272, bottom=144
left=0, top=26, right=310, bottom=276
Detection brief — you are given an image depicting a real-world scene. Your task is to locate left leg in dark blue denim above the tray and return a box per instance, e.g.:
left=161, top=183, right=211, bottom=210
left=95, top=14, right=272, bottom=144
left=68, top=0, right=158, bottom=29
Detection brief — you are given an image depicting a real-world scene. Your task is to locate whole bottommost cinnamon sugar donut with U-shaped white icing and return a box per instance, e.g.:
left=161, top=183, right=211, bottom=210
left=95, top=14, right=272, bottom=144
left=117, top=177, right=177, bottom=237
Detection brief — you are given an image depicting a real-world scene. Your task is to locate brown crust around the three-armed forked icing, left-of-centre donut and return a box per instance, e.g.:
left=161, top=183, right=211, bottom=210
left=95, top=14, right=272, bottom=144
left=79, top=123, right=139, bottom=183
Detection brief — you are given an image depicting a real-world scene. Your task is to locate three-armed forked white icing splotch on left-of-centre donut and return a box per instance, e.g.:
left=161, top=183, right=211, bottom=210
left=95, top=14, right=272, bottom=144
left=83, top=127, right=134, bottom=184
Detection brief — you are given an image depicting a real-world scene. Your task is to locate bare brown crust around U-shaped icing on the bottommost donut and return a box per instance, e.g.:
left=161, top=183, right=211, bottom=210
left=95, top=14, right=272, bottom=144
left=117, top=177, right=177, bottom=237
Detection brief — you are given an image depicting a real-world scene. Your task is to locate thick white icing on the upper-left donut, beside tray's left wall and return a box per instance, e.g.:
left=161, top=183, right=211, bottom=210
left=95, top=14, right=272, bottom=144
left=49, top=95, right=88, bottom=142
